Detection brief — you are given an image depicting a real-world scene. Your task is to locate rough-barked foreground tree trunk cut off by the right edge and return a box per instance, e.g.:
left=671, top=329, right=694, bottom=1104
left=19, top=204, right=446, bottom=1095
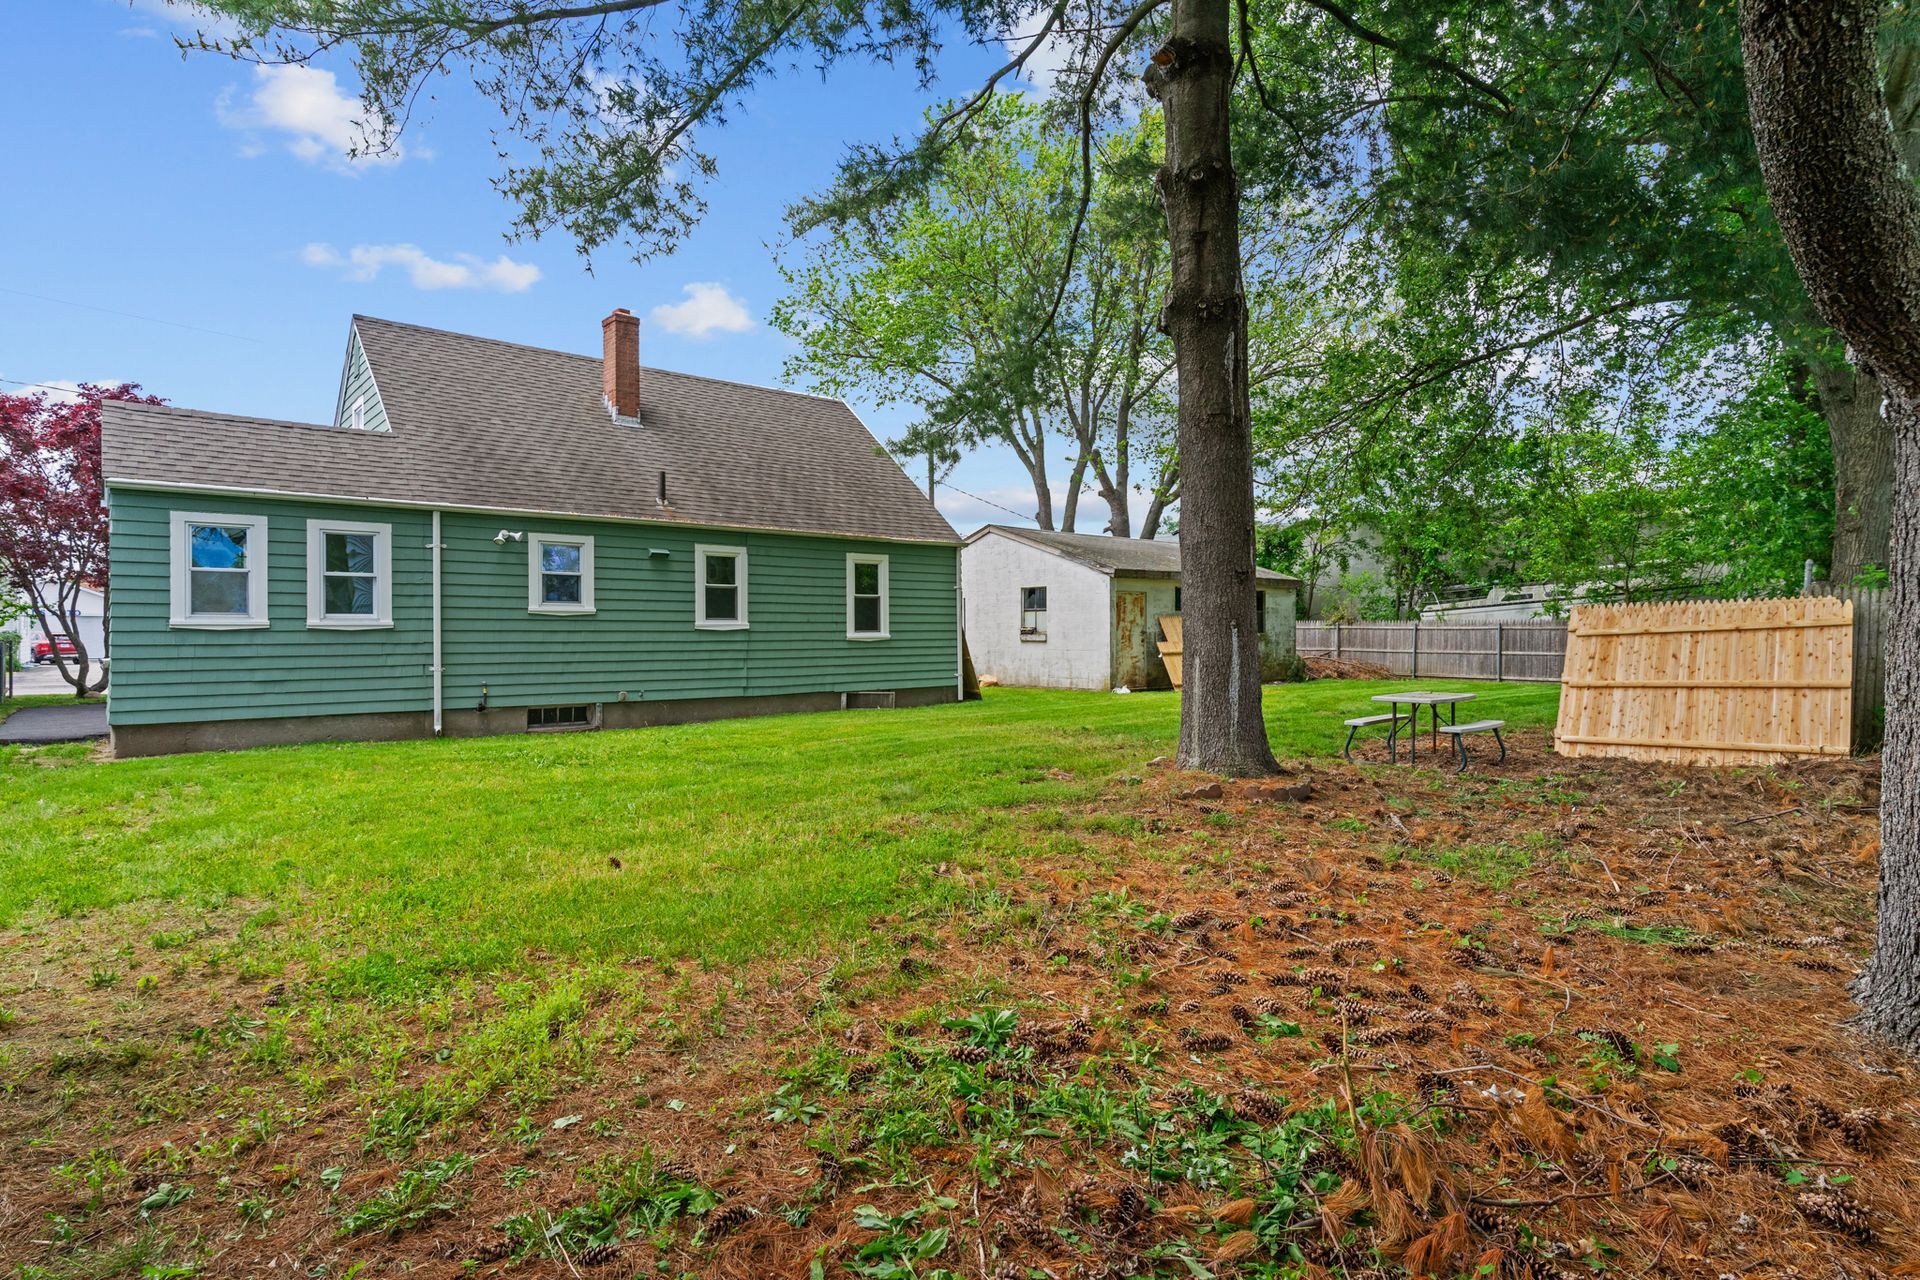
left=1740, top=0, right=1920, bottom=1048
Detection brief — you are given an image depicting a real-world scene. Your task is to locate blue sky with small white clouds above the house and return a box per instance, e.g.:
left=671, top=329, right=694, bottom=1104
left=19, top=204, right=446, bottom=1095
left=0, top=0, right=1067, bottom=532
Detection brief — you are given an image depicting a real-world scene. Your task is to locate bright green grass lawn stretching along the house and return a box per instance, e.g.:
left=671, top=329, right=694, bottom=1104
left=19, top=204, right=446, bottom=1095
left=0, top=681, right=1559, bottom=994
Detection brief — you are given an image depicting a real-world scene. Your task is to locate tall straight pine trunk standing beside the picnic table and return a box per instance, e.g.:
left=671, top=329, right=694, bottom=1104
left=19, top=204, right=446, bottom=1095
left=1146, top=0, right=1279, bottom=775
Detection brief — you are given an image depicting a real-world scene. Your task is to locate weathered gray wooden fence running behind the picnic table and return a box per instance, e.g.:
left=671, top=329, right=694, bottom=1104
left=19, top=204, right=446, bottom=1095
left=1294, top=618, right=1567, bottom=679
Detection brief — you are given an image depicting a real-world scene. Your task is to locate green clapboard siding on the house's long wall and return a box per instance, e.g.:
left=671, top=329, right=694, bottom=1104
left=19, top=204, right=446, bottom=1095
left=108, top=489, right=958, bottom=723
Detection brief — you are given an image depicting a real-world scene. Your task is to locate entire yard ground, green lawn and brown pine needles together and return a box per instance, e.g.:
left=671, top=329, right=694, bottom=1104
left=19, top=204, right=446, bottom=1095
left=0, top=683, right=1920, bottom=1278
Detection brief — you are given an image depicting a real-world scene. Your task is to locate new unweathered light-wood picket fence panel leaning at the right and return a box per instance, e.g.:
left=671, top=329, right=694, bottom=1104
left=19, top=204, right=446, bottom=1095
left=1553, top=597, right=1853, bottom=764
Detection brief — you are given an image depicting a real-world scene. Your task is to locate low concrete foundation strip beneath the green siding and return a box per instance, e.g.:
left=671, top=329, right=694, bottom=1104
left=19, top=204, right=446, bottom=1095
left=111, top=683, right=958, bottom=758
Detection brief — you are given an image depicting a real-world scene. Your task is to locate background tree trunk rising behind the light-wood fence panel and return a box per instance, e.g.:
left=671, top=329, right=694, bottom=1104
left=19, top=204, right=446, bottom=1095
left=1812, top=361, right=1893, bottom=583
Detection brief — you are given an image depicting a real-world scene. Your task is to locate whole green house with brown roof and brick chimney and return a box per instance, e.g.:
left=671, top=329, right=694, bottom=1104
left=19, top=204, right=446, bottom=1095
left=102, top=309, right=960, bottom=756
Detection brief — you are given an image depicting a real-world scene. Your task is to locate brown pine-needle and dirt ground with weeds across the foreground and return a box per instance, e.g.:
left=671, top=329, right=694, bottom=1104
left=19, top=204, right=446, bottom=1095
left=0, top=733, right=1896, bottom=1278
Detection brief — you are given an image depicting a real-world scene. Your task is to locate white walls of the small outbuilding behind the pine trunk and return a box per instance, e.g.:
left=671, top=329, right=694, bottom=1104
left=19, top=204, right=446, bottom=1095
left=960, top=524, right=1300, bottom=689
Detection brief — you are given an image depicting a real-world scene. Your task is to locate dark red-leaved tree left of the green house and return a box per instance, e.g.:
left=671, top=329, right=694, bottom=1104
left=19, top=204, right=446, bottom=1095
left=0, top=382, right=165, bottom=695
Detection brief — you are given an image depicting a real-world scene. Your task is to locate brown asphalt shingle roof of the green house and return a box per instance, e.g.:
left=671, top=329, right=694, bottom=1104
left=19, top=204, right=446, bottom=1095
left=102, top=317, right=956, bottom=543
